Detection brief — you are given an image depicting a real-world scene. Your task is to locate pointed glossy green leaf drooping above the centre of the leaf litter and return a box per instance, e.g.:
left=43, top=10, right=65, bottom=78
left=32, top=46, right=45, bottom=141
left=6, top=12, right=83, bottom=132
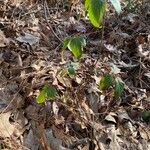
left=68, top=37, right=86, bottom=59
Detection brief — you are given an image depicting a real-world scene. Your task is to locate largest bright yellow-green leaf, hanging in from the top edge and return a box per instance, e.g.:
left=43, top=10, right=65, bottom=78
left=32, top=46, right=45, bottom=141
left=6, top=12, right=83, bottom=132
left=85, top=0, right=106, bottom=27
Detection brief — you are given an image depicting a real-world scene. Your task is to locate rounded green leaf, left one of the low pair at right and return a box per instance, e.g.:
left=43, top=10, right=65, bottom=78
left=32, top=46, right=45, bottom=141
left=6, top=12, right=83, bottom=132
left=99, top=74, right=114, bottom=90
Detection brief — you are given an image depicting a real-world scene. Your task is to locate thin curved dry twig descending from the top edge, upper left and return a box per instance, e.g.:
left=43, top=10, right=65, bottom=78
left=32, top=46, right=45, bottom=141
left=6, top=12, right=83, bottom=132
left=44, top=0, right=63, bottom=43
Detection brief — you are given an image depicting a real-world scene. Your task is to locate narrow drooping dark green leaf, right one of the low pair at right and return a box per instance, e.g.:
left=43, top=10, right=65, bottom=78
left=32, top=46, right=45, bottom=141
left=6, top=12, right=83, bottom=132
left=114, top=77, right=124, bottom=99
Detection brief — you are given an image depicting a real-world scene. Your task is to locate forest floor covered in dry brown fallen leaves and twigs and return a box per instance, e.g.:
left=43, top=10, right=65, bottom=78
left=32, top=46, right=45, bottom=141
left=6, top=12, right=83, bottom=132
left=0, top=0, right=150, bottom=150
